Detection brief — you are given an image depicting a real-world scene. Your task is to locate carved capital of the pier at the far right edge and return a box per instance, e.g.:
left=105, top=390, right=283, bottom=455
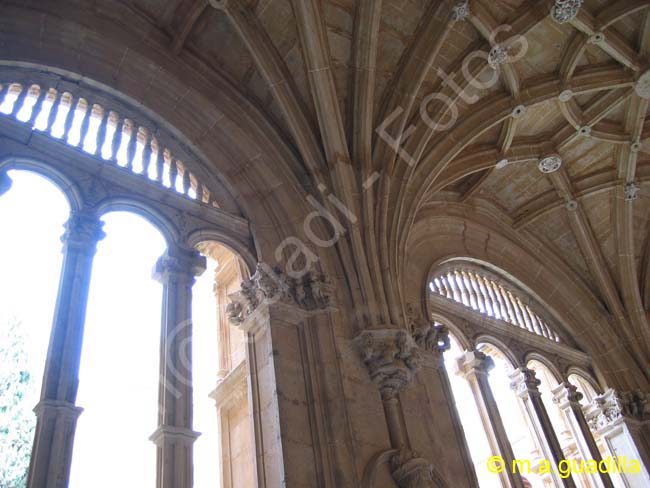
left=586, top=389, right=650, bottom=430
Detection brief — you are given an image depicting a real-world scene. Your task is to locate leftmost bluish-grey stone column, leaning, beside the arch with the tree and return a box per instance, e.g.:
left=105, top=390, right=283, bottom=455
left=27, top=211, right=104, bottom=488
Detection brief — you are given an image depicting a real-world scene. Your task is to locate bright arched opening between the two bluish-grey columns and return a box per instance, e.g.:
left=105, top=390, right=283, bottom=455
left=70, top=211, right=167, bottom=488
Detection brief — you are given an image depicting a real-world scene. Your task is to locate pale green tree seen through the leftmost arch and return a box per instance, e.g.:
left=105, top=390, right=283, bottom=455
left=0, top=319, right=36, bottom=488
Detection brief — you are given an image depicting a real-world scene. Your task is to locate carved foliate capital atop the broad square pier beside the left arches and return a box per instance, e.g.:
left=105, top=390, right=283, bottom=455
left=226, top=263, right=332, bottom=326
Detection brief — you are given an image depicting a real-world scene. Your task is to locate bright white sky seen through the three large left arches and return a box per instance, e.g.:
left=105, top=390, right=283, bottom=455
left=0, top=171, right=220, bottom=488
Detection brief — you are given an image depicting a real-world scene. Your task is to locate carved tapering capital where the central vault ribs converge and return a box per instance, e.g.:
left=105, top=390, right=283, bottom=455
left=355, top=329, right=420, bottom=400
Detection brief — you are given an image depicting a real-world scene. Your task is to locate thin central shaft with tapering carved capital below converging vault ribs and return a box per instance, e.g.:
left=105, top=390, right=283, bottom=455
left=356, top=327, right=446, bottom=488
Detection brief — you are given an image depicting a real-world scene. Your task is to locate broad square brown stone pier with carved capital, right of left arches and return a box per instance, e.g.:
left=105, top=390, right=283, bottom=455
left=227, top=263, right=335, bottom=488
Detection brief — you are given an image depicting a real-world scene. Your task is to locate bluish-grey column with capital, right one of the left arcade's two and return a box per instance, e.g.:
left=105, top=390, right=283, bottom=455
left=151, top=246, right=205, bottom=488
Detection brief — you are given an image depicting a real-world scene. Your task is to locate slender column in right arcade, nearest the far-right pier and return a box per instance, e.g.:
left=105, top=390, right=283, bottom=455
left=553, top=382, right=614, bottom=488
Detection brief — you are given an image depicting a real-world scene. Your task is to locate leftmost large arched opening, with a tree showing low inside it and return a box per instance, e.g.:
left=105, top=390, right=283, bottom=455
left=0, top=170, right=70, bottom=486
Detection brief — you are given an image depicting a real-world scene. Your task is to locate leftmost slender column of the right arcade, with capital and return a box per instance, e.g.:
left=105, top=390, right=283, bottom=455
left=456, top=351, right=524, bottom=488
